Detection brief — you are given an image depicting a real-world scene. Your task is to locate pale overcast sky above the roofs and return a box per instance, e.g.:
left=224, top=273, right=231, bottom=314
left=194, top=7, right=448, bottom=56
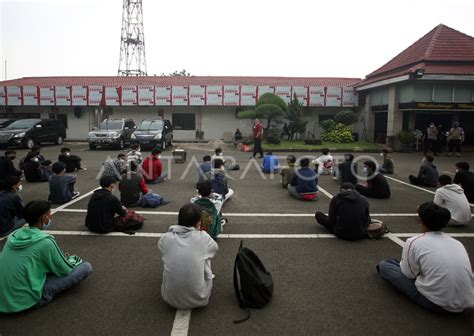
left=0, top=0, right=474, bottom=79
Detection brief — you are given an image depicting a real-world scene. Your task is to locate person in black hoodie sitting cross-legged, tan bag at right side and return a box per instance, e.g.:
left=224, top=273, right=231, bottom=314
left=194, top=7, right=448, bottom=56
left=315, top=182, right=370, bottom=240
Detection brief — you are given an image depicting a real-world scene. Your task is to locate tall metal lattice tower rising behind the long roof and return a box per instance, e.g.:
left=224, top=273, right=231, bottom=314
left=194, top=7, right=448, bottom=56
left=118, top=0, right=147, bottom=76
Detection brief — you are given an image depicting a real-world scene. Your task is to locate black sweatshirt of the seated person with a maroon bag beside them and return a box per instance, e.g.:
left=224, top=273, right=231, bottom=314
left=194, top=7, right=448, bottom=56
left=86, top=189, right=127, bottom=233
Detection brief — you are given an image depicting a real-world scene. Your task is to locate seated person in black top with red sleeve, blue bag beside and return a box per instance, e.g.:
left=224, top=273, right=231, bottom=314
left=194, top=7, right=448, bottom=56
left=119, top=161, right=150, bottom=207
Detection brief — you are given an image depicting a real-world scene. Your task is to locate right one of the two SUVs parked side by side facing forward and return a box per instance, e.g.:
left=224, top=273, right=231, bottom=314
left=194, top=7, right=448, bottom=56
left=132, top=119, right=173, bottom=150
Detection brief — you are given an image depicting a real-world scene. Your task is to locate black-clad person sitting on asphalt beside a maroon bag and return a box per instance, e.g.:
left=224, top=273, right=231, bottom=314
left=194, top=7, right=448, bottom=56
left=86, top=176, right=127, bottom=233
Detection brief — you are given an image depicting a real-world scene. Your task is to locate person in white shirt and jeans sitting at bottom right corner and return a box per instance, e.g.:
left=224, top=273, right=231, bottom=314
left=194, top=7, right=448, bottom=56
left=377, top=202, right=474, bottom=313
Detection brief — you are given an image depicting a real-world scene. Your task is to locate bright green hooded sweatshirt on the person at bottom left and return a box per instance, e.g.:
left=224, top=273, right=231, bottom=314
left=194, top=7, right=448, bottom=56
left=0, top=227, right=75, bottom=313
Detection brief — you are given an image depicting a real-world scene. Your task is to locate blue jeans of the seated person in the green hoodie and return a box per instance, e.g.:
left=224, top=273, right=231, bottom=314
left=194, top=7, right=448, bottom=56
left=36, top=261, right=92, bottom=308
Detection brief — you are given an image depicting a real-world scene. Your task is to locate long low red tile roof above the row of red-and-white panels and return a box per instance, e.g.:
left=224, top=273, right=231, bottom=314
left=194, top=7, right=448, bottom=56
left=0, top=76, right=360, bottom=87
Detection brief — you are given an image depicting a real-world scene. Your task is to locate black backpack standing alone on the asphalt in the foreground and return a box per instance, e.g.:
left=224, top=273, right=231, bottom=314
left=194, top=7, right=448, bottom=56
left=234, top=241, right=273, bottom=323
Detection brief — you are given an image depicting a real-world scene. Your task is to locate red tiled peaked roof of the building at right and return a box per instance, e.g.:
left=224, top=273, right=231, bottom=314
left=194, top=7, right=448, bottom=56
left=355, top=24, right=474, bottom=86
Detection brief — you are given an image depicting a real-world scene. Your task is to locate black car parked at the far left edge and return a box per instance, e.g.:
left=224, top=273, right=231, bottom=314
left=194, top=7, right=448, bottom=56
left=0, top=119, right=66, bottom=148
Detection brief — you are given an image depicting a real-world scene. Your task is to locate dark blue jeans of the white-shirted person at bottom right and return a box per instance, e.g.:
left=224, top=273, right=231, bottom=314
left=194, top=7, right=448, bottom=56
left=379, top=259, right=445, bottom=313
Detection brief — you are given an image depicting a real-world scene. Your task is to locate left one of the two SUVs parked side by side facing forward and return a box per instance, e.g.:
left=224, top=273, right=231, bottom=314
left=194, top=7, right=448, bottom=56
left=87, top=119, right=136, bottom=149
